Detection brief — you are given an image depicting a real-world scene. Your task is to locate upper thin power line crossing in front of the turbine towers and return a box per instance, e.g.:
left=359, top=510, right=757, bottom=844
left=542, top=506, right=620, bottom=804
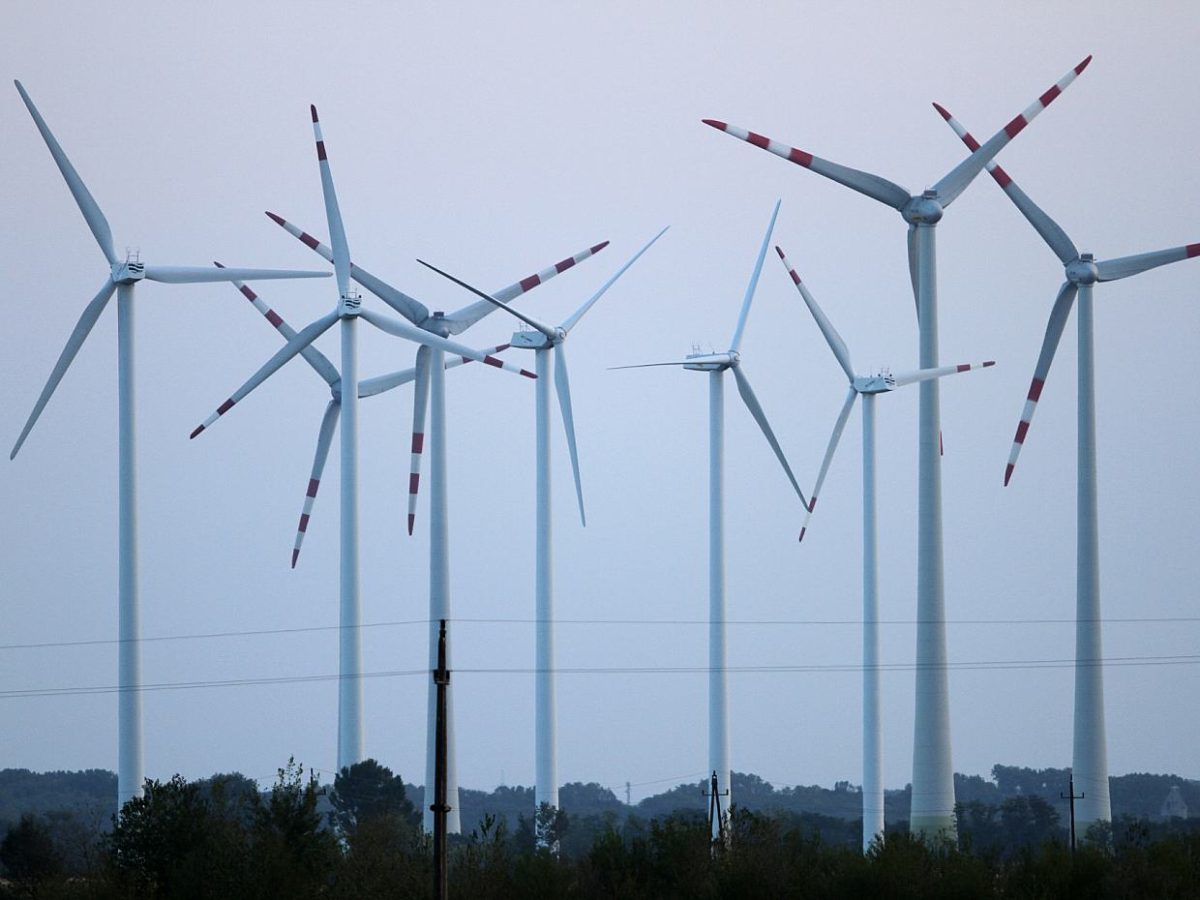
left=0, top=616, right=1200, bottom=650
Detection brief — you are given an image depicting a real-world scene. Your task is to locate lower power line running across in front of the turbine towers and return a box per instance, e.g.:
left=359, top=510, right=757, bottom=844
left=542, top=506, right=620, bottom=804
left=0, top=655, right=1200, bottom=700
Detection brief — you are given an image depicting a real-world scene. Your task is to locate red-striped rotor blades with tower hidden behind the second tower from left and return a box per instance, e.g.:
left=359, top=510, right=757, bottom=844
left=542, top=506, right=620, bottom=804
left=216, top=263, right=536, bottom=569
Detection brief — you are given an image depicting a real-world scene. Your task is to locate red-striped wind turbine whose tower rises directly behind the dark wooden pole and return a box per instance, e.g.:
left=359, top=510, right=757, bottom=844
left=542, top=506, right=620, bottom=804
left=258, top=212, right=608, bottom=833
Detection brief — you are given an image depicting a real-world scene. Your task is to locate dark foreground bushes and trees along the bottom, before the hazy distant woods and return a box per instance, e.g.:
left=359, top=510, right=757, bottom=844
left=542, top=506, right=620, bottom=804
left=0, top=761, right=1200, bottom=900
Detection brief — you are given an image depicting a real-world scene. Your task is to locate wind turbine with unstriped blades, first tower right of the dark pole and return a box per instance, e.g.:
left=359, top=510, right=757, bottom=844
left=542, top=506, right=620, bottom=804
left=418, top=228, right=667, bottom=830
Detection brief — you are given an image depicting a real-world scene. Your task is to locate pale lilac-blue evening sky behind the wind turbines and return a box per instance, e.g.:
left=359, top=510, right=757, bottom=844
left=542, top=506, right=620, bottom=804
left=0, top=0, right=1200, bottom=800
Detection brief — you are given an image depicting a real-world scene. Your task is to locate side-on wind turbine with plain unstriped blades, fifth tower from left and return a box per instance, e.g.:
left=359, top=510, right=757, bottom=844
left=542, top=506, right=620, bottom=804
left=618, top=202, right=809, bottom=840
